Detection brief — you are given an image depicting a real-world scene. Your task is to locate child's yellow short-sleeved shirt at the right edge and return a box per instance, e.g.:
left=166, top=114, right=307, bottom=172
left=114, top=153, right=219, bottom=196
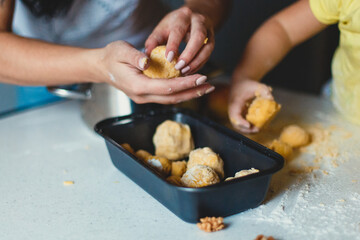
left=310, top=0, right=360, bottom=124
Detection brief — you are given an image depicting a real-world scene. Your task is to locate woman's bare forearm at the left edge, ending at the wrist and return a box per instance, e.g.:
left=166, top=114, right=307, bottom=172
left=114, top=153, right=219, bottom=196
left=0, top=32, right=100, bottom=85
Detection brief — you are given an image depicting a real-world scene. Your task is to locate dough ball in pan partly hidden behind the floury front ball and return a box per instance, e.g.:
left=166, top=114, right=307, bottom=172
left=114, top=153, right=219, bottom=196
left=187, top=147, right=224, bottom=179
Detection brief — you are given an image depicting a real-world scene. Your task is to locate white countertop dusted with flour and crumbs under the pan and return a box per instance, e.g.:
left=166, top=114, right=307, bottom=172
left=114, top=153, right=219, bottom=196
left=0, top=91, right=360, bottom=240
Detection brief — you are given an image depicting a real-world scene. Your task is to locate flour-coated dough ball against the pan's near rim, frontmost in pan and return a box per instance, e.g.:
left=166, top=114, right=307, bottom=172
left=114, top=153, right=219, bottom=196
left=181, top=165, right=220, bottom=188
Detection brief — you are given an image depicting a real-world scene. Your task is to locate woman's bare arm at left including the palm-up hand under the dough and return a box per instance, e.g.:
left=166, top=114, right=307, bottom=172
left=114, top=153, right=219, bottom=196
left=0, top=0, right=212, bottom=104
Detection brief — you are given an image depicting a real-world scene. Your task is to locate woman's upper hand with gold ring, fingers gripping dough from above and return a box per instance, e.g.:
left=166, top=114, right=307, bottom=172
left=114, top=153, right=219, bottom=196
left=145, top=7, right=215, bottom=75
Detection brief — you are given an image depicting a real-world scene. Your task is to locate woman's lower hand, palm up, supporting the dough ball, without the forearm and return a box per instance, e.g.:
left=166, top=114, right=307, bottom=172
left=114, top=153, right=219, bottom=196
left=98, top=41, right=215, bottom=104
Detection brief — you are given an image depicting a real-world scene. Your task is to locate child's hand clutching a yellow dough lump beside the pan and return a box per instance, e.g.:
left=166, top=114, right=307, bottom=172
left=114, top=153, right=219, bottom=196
left=229, top=78, right=274, bottom=133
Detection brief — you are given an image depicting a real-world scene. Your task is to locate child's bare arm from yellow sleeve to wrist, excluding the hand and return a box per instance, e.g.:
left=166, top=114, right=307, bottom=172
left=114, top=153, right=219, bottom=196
left=234, top=0, right=327, bottom=81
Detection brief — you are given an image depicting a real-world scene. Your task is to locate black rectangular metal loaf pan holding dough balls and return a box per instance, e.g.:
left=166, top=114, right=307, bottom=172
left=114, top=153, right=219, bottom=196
left=95, top=108, right=284, bottom=222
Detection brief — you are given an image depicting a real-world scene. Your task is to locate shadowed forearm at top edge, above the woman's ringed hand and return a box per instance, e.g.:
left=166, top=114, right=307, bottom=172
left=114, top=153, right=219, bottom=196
left=185, top=0, right=230, bottom=29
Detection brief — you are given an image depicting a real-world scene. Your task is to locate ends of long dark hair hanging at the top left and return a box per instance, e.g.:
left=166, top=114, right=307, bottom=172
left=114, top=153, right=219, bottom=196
left=22, top=0, right=74, bottom=18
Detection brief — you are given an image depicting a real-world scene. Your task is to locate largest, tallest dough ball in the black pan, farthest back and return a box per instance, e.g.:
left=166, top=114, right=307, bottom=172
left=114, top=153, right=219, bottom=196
left=153, top=120, right=194, bottom=161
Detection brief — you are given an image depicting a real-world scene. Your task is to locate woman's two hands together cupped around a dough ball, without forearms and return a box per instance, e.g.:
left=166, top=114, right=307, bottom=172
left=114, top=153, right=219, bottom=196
left=100, top=7, right=215, bottom=104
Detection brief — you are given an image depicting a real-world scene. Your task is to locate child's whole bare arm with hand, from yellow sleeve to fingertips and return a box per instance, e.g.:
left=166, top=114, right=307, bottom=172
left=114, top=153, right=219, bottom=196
left=229, top=0, right=327, bottom=133
